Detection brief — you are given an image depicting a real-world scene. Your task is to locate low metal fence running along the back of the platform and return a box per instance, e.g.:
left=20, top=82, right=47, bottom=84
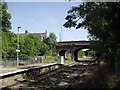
left=0, top=56, right=57, bottom=67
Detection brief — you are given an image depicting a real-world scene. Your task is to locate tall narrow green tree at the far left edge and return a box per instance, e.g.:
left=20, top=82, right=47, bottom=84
left=0, top=2, right=12, bottom=57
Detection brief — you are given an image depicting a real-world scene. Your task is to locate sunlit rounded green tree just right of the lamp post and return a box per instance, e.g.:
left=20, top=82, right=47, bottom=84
left=20, top=34, right=48, bottom=56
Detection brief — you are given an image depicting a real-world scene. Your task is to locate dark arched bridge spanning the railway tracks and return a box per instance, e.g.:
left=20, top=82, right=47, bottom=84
left=56, top=41, right=92, bottom=61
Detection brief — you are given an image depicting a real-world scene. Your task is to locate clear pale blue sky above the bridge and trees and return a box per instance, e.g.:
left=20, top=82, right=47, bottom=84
left=8, top=2, right=88, bottom=41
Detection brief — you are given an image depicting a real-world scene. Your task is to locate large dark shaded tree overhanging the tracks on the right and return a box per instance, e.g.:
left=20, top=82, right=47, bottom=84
left=64, top=2, right=120, bottom=69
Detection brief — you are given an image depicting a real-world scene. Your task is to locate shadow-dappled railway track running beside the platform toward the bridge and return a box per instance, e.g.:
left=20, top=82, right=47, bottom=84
left=3, top=63, right=97, bottom=90
